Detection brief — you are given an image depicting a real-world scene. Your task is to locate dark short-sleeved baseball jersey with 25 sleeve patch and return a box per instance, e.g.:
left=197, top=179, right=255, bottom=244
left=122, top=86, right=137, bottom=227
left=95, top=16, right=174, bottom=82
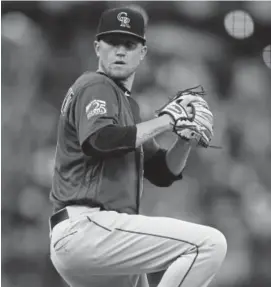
left=50, top=72, right=150, bottom=213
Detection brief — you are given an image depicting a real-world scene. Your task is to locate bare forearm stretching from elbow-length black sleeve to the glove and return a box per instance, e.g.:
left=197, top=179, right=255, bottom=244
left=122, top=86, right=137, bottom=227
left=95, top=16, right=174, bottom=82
left=136, top=115, right=172, bottom=147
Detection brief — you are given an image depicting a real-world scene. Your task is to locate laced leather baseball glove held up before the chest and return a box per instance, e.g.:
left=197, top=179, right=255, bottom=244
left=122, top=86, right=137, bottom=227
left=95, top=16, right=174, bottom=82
left=156, top=86, right=218, bottom=148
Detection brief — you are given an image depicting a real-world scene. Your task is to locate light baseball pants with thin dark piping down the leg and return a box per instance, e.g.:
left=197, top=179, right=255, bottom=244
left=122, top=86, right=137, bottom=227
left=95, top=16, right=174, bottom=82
left=50, top=206, right=227, bottom=287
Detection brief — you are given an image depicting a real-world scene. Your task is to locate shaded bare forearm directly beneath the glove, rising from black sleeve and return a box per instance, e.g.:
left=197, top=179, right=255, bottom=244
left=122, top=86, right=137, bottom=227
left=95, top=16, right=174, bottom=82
left=166, top=138, right=191, bottom=175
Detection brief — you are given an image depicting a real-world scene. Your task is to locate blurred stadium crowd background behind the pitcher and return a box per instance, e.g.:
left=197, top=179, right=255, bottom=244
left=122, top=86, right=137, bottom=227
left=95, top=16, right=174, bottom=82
left=1, top=1, right=271, bottom=287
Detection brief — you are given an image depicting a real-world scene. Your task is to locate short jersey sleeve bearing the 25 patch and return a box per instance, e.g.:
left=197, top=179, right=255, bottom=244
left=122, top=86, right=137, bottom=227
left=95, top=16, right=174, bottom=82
left=75, top=82, right=119, bottom=145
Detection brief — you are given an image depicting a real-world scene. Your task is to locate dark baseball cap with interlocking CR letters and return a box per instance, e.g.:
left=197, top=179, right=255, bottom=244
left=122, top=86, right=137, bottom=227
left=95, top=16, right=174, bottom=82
left=96, top=8, right=146, bottom=43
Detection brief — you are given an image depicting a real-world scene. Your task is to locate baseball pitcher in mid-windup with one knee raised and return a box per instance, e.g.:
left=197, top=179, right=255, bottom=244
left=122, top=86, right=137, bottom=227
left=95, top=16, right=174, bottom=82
left=49, top=8, right=227, bottom=287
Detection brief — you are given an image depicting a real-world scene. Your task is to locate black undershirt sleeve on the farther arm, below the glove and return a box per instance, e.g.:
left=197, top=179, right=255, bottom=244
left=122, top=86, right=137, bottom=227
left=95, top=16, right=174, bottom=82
left=144, top=149, right=183, bottom=187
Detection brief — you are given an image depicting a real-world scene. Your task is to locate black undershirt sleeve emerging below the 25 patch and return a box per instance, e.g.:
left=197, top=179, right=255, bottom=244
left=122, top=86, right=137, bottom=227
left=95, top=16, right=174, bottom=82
left=82, top=125, right=137, bottom=157
